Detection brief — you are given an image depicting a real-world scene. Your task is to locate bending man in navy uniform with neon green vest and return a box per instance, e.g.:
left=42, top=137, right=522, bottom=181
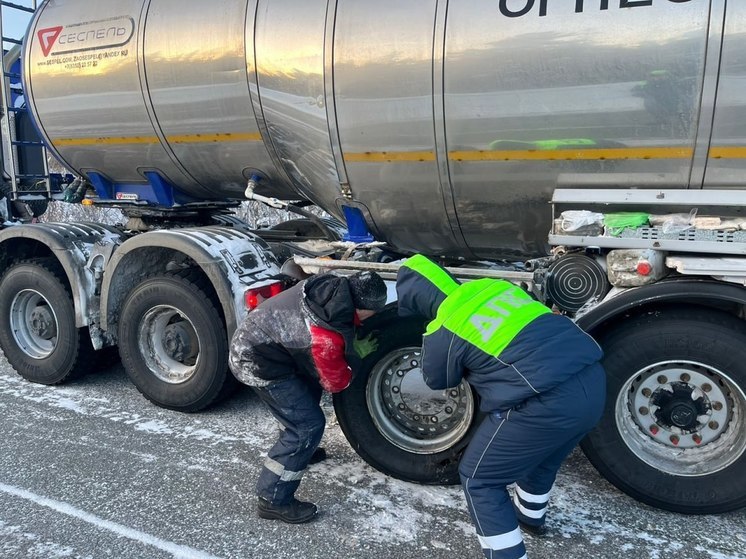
left=396, top=255, right=605, bottom=559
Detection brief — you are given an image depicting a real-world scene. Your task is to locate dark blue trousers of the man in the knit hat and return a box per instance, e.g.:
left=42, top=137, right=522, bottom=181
left=253, top=375, right=326, bottom=505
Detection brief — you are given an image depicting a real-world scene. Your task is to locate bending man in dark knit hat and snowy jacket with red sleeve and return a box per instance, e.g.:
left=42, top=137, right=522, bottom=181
left=230, top=272, right=386, bottom=524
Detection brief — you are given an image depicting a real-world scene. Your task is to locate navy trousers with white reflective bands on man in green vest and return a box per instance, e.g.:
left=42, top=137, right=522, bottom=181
left=459, top=364, right=606, bottom=559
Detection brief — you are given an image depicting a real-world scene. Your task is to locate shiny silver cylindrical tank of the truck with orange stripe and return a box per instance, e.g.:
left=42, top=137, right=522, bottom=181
left=24, top=0, right=746, bottom=258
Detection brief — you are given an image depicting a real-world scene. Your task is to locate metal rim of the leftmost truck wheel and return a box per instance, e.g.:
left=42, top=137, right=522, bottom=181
left=10, top=289, right=59, bottom=359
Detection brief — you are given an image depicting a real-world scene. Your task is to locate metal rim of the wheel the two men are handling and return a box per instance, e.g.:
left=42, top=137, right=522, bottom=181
left=366, top=347, right=474, bottom=454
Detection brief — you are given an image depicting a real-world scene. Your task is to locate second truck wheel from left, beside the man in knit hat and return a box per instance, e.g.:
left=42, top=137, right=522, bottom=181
left=119, top=273, right=230, bottom=412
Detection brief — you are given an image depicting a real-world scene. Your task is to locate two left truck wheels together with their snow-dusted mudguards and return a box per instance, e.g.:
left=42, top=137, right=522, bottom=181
left=0, top=220, right=280, bottom=411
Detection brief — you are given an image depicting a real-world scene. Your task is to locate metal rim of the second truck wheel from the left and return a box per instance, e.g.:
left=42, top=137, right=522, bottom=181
left=137, top=305, right=200, bottom=384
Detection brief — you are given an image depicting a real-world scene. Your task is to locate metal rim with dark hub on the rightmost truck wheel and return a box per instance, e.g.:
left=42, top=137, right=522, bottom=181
left=616, top=361, right=746, bottom=476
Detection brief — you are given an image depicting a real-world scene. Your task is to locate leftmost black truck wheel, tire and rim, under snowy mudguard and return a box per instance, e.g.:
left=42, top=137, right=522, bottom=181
left=0, top=258, right=93, bottom=385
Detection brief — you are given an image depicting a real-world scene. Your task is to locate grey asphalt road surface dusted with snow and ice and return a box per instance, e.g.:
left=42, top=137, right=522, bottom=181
left=0, top=359, right=746, bottom=559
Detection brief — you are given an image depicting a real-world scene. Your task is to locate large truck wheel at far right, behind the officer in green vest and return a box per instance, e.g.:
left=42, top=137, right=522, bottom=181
left=581, top=307, right=746, bottom=514
